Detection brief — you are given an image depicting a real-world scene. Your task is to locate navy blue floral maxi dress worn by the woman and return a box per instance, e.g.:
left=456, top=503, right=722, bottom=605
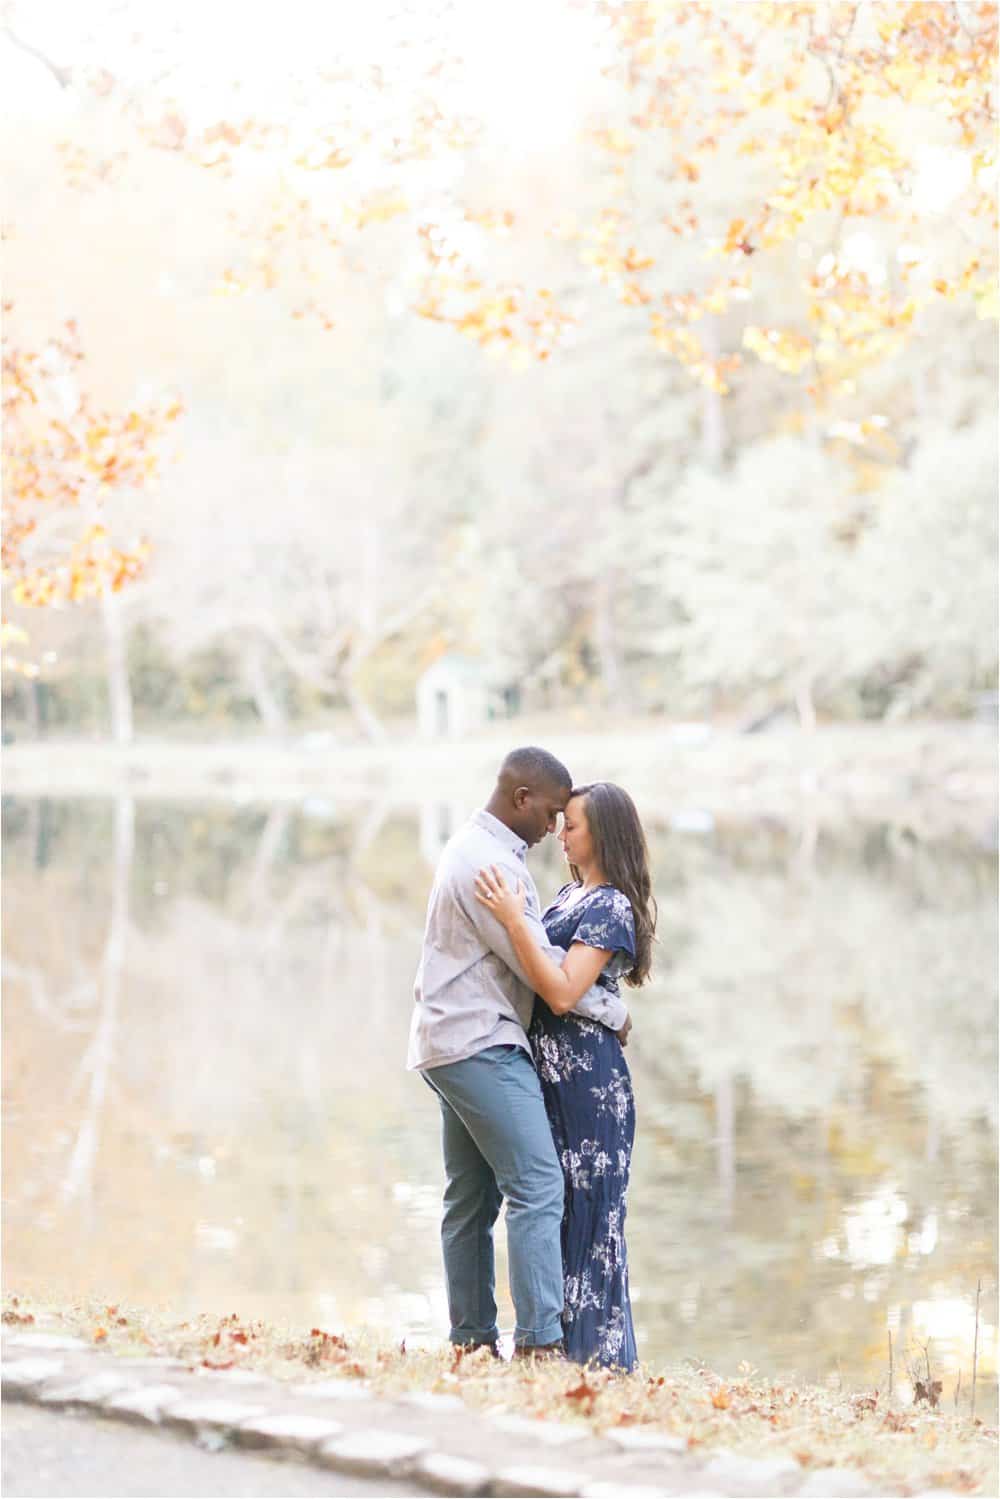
left=529, top=884, right=637, bottom=1370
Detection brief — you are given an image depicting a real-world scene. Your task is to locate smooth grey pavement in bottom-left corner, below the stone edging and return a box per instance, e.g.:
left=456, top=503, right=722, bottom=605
left=3, top=1405, right=423, bottom=1499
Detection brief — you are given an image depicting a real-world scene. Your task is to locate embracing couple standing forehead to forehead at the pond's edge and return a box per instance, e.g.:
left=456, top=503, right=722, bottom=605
left=408, top=748, right=657, bottom=1370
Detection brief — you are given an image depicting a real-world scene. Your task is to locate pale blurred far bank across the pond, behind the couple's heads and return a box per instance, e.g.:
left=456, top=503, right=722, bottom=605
left=3, top=721, right=997, bottom=848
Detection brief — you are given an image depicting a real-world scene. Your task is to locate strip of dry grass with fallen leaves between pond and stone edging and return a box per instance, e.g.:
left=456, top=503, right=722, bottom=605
left=3, top=1297, right=997, bottom=1493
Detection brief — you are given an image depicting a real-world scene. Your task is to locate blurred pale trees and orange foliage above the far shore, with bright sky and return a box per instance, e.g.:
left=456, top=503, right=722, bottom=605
left=0, top=0, right=997, bottom=738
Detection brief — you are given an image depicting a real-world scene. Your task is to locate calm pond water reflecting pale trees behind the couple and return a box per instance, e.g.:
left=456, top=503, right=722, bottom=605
left=4, top=797, right=997, bottom=1409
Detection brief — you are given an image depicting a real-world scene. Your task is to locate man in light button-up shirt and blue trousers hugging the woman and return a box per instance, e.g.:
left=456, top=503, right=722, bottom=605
left=406, top=748, right=631, bottom=1357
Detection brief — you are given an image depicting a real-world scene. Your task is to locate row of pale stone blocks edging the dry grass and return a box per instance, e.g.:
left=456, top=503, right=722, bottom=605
left=3, top=1333, right=957, bottom=1499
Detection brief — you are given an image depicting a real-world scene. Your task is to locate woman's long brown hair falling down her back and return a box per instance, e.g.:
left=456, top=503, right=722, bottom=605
left=570, top=781, right=657, bottom=989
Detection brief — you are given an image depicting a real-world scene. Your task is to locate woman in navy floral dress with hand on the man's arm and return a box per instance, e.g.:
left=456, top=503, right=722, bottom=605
left=477, top=781, right=657, bottom=1370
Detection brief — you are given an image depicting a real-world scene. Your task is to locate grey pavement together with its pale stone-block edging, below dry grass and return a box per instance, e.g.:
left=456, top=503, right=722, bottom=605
left=3, top=1331, right=957, bottom=1499
